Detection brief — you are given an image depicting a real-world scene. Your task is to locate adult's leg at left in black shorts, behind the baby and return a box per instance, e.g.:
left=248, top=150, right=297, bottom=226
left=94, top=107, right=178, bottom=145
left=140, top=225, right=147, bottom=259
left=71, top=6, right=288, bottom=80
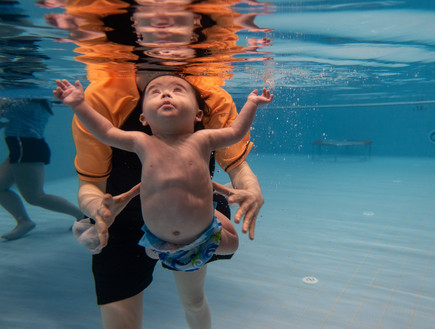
left=92, top=237, right=156, bottom=329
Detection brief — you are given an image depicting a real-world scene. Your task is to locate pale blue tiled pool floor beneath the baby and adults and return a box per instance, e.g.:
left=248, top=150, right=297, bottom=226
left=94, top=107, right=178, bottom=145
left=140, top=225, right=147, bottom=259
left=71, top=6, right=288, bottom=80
left=0, top=153, right=435, bottom=329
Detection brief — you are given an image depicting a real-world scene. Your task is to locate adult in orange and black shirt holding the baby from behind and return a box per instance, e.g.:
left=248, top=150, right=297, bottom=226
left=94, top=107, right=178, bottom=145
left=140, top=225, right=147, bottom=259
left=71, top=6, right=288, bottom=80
left=56, top=2, right=270, bottom=329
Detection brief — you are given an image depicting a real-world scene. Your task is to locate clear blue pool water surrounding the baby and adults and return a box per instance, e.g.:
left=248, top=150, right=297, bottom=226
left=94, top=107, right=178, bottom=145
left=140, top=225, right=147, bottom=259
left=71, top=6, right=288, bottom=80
left=0, top=0, right=435, bottom=329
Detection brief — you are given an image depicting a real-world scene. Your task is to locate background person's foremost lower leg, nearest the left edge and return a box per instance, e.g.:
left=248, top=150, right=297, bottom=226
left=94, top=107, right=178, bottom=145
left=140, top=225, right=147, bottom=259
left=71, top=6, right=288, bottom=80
left=0, top=159, right=35, bottom=240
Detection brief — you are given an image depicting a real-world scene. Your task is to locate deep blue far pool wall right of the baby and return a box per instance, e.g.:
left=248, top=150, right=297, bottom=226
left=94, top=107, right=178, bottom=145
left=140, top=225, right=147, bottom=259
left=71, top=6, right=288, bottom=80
left=249, top=104, right=435, bottom=157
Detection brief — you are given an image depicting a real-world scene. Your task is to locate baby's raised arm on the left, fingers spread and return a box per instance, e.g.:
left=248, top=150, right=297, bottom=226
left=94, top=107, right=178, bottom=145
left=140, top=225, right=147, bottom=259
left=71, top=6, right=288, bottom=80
left=53, top=80, right=141, bottom=151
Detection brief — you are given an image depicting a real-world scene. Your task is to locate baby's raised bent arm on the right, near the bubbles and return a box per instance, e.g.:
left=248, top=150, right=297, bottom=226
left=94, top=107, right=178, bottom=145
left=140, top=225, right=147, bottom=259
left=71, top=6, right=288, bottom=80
left=210, top=88, right=273, bottom=149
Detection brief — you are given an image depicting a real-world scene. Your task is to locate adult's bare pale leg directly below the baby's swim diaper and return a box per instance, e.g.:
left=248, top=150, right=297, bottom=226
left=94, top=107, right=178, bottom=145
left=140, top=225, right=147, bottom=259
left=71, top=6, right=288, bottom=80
left=173, top=265, right=211, bottom=329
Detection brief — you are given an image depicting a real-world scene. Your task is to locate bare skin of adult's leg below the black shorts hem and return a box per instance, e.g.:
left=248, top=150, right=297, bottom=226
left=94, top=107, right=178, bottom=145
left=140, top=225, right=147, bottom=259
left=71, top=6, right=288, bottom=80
left=100, top=291, right=144, bottom=329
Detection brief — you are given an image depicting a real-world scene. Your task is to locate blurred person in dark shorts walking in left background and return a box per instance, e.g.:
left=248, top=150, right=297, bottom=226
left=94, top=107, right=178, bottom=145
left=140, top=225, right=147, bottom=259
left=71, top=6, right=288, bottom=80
left=0, top=98, right=83, bottom=240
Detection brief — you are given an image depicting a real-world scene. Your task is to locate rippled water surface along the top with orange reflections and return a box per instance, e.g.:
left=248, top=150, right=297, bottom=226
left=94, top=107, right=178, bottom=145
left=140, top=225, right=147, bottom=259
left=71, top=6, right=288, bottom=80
left=0, top=0, right=435, bottom=107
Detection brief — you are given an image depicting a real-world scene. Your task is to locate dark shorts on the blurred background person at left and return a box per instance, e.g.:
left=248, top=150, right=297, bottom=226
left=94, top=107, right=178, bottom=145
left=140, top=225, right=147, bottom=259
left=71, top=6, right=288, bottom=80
left=5, top=136, right=50, bottom=164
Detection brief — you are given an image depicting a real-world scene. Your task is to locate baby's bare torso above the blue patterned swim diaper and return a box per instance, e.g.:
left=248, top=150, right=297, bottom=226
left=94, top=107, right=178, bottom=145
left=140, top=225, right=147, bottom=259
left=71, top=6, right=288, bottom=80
left=138, top=135, right=213, bottom=244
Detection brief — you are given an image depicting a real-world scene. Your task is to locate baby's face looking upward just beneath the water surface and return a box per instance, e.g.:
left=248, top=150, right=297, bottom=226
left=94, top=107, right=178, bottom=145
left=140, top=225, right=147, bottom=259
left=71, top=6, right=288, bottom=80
left=141, top=76, right=202, bottom=129
